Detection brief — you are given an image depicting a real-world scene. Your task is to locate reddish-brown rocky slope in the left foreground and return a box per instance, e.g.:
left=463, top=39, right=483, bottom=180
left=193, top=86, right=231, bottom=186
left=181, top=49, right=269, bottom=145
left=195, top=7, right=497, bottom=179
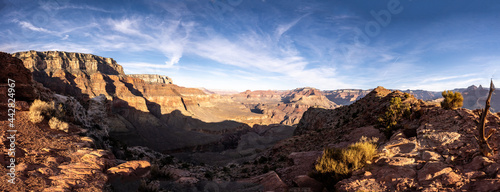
left=0, top=53, right=151, bottom=191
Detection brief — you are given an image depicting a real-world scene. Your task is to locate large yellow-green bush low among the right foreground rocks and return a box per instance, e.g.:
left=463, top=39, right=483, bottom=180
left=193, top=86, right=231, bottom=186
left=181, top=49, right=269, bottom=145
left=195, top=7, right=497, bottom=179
left=312, top=139, right=377, bottom=190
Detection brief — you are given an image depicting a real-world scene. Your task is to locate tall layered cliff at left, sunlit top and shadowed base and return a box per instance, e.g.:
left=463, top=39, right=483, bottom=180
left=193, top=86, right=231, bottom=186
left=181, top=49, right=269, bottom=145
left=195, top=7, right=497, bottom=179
left=12, top=51, right=286, bottom=154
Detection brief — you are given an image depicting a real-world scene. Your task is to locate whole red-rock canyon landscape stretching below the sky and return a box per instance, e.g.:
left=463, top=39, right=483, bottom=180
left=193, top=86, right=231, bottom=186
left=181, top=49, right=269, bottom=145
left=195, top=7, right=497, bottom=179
left=0, top=51, right=500, bottom=191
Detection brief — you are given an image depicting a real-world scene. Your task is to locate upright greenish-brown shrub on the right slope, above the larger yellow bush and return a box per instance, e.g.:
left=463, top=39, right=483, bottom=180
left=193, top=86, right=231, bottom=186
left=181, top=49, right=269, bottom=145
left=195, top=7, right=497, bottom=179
left=378, top=97, right=411, bottom=137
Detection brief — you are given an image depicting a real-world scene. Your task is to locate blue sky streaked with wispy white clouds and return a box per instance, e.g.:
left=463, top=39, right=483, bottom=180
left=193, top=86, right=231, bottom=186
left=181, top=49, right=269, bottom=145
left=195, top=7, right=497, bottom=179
left=0, top=0, right=500, bottom=91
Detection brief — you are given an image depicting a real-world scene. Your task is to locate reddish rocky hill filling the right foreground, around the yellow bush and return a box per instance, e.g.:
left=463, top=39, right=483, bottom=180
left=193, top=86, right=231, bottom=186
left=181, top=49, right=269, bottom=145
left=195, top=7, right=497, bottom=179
left=252, top=87, right=500, bottom=191
